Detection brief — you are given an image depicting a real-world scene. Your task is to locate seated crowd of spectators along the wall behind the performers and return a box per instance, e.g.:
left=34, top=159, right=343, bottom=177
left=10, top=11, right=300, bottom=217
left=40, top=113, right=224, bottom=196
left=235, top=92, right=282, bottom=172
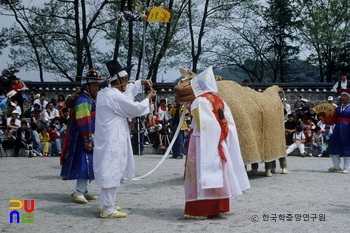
left=0, top=71, right=350, bottom=159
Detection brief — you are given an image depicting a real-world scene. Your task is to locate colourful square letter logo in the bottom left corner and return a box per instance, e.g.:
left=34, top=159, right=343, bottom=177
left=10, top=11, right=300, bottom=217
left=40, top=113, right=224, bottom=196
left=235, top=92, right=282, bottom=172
left=10, top=200, right=35, bottom=224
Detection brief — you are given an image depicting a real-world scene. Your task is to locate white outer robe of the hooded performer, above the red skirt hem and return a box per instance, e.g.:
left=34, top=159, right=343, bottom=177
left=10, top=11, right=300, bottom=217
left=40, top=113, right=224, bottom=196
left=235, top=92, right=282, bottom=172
left=185, top=97, right=250, bottom=201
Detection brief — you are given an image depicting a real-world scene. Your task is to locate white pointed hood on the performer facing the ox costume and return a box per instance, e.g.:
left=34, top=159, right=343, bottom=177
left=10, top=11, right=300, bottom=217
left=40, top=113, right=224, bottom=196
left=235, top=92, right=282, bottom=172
left=191, top=66, right=218, bottom=97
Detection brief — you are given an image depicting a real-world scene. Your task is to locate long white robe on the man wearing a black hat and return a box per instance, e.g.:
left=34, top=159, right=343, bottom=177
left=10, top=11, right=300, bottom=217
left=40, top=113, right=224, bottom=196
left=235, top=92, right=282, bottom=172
left=93, top=82, right=149, bottom=188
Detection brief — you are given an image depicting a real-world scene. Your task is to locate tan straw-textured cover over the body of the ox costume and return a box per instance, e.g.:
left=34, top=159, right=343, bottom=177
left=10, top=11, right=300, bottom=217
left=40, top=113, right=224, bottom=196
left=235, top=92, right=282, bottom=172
left=217, top=80, right=286, bottom=164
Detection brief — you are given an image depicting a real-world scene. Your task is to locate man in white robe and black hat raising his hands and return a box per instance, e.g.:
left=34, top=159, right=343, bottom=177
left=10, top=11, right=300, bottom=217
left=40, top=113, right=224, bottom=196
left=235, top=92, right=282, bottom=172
left=93, top=70, right=156, bottom=218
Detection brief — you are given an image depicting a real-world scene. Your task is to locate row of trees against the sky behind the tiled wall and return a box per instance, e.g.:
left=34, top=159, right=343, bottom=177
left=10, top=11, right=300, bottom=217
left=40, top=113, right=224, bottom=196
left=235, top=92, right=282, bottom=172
left=0, top=0, right=350, bottom=83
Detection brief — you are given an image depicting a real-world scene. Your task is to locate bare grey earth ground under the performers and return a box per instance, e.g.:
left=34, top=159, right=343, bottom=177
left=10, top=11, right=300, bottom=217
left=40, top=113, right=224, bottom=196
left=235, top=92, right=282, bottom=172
left=0, top=154, right=350, bottom=232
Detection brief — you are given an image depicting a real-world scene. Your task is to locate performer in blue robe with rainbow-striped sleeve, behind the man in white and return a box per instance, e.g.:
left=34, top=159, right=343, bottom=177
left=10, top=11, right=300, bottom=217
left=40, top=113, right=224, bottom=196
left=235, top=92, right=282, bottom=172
left=61, top=69, right=101, bottom=204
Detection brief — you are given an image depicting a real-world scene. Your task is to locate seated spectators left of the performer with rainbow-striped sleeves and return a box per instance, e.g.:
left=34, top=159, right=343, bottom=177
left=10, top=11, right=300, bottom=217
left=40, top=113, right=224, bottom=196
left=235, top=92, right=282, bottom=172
left=0, top=82, right=71, bottom=157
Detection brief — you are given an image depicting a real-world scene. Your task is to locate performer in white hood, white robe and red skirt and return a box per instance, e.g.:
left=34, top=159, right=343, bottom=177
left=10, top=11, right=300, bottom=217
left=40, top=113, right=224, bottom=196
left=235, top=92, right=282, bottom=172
left=184, top=67, right=250, bottom=219
